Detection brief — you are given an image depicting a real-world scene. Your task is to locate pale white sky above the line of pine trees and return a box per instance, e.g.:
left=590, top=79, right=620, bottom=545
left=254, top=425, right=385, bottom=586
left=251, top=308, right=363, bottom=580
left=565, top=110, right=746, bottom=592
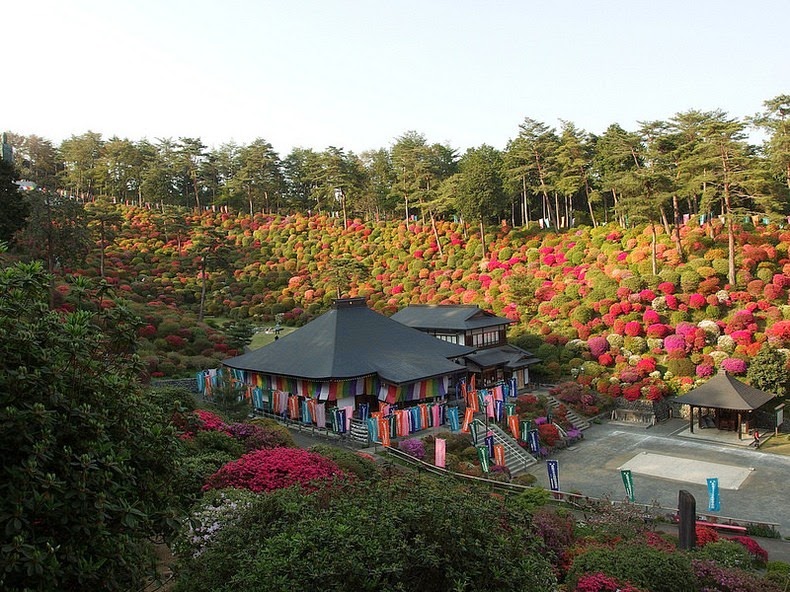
left=6, top=0, right=790, bottom=157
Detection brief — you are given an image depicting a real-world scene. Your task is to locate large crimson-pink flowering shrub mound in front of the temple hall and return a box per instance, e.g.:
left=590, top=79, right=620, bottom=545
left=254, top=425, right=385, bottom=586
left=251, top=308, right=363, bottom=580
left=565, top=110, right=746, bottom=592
left=203, top=448, right=343, bottom=493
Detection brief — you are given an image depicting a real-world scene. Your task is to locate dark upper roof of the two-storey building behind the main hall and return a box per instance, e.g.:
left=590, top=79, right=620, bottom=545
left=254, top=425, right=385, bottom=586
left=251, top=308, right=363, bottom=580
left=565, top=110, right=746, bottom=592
left=390, top=304, right=513, bottom=331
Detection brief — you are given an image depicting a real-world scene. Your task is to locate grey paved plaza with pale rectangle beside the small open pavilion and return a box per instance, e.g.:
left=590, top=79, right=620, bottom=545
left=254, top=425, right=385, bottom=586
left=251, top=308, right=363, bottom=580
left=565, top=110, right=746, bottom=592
left=529, top=419, right=790, bottom=536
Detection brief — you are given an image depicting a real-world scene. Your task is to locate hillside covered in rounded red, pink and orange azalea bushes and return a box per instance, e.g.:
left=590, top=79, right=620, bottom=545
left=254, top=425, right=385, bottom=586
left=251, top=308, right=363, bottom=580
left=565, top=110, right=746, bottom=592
left=63, top=207, right=790, bottom=398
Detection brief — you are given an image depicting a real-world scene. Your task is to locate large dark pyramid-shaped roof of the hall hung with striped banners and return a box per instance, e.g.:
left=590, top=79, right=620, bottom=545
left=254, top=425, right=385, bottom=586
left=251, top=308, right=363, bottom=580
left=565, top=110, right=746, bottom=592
left=223, top=298, right=472, bottom=384
